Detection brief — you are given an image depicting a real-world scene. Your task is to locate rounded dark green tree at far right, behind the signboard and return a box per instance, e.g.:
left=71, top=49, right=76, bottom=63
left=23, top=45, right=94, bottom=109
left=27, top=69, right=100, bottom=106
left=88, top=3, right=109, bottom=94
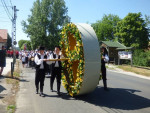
left=115, top=13, right=149, bottom=49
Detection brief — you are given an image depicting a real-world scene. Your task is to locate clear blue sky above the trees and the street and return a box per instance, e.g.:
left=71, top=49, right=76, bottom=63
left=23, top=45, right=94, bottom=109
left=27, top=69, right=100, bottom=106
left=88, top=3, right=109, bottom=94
left=0, top=0, right=150, bottom=46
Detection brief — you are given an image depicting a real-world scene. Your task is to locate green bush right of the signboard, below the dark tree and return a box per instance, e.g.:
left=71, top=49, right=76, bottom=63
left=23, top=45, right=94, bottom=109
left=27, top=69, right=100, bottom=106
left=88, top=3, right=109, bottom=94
left=133, top=50, right=150, bottom=67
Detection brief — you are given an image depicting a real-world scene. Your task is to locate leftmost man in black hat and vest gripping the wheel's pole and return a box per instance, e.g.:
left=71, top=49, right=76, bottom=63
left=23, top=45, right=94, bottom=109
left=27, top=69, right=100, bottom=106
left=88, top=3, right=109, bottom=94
left=35, top=46, right=47, bottom=97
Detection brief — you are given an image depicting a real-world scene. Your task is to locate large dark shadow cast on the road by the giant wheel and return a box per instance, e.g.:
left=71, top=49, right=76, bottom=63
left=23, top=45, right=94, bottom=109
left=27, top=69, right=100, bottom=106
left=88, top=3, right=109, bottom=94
left=75, top=87, right=150, bottom=110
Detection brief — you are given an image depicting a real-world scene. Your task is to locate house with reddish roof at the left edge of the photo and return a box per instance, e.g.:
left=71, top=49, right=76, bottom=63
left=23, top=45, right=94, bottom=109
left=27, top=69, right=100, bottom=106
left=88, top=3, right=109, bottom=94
left=0, top=29, right=8, bottom=48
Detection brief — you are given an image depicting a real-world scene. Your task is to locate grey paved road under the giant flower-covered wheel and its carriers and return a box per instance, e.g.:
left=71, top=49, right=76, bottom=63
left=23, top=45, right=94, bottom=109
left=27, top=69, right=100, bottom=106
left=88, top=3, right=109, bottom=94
left=16, top=68, right=150, bottom=113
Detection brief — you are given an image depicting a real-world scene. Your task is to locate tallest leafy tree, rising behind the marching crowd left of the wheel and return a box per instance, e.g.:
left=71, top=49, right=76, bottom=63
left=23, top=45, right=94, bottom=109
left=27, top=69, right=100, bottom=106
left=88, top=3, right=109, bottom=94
left=22, top=0, right=70, bottom=49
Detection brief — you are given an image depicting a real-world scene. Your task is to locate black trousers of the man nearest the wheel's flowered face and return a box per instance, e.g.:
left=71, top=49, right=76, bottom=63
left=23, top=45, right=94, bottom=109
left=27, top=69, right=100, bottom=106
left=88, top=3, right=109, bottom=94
left=50, top=67, right=61, bottom=92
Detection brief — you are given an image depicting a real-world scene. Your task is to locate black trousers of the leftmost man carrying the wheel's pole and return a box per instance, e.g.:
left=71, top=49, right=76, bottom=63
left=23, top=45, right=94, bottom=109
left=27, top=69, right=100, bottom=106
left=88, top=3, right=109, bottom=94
left=35, top=69, right=45, bottom=92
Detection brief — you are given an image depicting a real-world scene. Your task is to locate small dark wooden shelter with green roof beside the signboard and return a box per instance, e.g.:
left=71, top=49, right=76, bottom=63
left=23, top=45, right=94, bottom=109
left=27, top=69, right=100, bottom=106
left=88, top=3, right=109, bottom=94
left=100, top=41, right=132, bottom=64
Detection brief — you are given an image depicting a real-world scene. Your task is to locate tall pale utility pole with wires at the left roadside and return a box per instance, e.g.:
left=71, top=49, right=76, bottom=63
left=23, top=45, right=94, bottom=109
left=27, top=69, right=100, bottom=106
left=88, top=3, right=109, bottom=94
left=11, top=6, right=19, bottom=77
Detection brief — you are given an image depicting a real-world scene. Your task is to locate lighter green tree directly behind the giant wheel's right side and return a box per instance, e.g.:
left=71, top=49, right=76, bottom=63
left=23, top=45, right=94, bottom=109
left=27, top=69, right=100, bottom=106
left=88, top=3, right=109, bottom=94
left=92, top=14, right=120, bottom=41
